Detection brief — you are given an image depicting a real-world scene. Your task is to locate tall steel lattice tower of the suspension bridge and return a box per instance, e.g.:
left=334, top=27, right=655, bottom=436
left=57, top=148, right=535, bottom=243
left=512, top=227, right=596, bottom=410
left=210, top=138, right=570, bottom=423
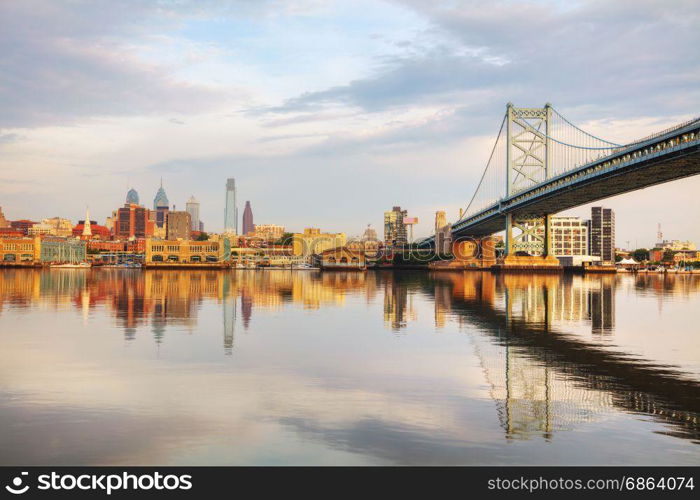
left=505, top=103, right=558, bottom=265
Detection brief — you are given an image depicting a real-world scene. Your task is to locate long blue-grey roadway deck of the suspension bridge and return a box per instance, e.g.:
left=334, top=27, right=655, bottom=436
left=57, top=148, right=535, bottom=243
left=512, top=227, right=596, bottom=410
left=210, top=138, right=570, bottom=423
left=420, top=120, right=700, bottom=242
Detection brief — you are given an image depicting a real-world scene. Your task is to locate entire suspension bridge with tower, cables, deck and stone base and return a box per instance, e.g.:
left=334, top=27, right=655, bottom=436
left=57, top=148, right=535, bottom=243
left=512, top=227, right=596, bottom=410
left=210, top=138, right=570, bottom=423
left=419, top=103, right=700, bottom=268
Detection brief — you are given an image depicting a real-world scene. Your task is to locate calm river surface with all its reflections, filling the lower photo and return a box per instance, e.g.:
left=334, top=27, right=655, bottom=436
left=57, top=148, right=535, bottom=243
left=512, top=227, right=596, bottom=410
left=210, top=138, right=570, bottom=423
left=0, top=269, right=700, bottom=465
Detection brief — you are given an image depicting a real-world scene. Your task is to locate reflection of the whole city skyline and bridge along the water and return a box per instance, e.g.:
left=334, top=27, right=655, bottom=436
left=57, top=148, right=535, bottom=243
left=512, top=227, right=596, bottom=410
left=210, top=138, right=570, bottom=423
left=0, top=270, right=700, bottom=442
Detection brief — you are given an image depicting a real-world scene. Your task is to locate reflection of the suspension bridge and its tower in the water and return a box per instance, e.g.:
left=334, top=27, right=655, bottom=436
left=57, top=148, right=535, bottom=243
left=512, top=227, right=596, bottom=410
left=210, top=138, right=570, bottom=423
left=433, top=273, right=700, bottom=441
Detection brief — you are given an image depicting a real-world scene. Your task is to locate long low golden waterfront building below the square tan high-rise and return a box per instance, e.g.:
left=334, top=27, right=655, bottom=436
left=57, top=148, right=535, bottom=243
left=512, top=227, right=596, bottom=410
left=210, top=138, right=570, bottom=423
left=144, top=238, right=230, bottom=266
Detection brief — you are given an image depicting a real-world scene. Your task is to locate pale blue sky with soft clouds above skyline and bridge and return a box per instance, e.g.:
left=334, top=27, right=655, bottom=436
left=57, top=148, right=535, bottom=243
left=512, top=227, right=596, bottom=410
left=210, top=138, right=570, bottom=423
left=0, top=0, right=700, bottom=247
